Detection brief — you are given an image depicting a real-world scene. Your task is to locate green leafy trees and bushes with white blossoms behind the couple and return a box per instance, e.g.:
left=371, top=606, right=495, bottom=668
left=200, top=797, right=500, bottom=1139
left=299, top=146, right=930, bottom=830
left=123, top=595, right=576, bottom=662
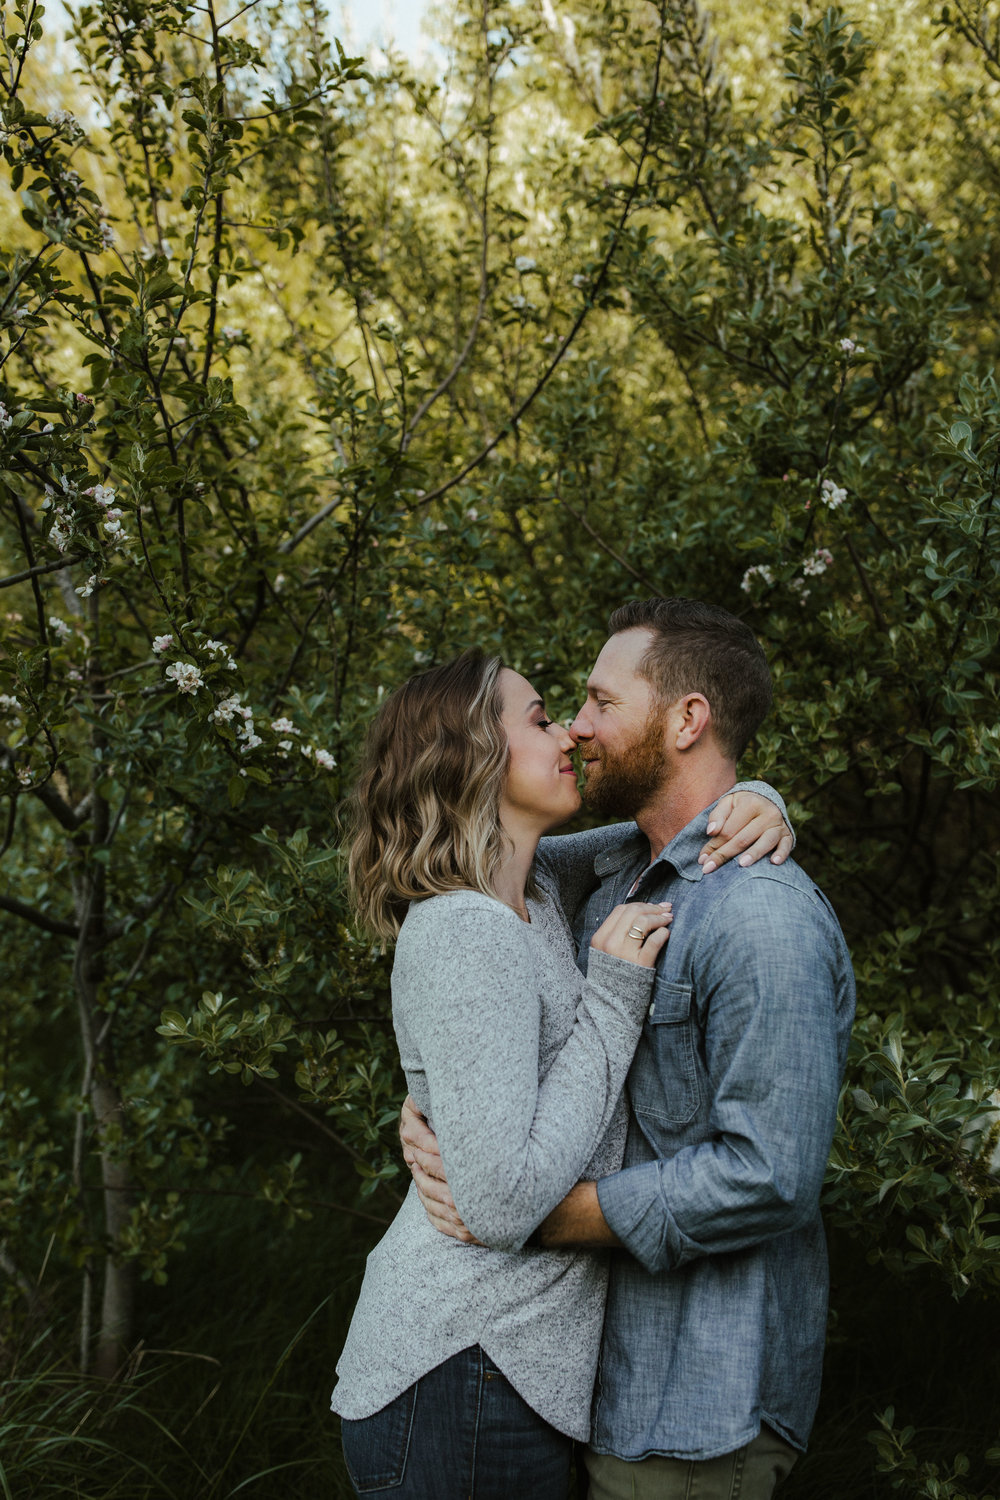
left=0, top=0, right=1000, bottom=1496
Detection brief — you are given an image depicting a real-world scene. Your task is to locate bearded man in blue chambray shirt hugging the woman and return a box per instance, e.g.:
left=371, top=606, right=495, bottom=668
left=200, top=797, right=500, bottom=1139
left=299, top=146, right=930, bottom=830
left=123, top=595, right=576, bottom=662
left=408, top=599, right=855, bottom=1500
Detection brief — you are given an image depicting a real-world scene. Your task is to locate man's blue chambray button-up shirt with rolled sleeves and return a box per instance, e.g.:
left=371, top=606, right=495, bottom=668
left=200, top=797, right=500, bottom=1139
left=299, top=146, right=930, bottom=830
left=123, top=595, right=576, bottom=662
left=576, top=815, right=855, bottom=1460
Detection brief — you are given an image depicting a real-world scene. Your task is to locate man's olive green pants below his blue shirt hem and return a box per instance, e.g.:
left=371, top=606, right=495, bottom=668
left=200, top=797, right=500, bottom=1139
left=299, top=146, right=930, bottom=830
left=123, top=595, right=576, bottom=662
left=586, top=1427, right=799, bottom=1500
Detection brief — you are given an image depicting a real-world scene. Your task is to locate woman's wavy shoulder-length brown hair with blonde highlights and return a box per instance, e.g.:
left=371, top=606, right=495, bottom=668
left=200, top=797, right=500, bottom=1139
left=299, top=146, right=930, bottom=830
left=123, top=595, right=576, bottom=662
left=348, top=650, right=510, bottom=944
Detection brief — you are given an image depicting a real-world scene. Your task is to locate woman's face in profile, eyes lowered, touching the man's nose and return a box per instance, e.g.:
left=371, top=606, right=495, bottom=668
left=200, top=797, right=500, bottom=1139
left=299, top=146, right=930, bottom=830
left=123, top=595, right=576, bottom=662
left=499, top=668, right=580, bottom=836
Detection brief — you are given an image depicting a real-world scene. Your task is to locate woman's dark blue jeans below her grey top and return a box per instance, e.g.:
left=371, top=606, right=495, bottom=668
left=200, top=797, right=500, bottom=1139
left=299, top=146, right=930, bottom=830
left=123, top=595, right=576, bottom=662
left=340, top=1344, right=573, bottom=1500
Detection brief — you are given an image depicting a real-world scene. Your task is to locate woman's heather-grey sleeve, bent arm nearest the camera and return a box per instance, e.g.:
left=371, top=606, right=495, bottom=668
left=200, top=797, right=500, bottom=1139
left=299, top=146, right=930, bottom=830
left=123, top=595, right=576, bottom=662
left=403, top=899, right=654, bottom=1250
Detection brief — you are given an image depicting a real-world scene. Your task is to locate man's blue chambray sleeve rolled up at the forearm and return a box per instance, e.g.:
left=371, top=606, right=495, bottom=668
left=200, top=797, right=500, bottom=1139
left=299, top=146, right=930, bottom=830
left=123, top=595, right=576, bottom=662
left=598, top=878, right=853, bottom=1272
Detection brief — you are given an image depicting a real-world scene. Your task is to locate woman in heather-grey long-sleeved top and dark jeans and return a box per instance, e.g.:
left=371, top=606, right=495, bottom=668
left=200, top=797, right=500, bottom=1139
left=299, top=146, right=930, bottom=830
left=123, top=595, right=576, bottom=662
left=331, top=651, right=785, bottom=1500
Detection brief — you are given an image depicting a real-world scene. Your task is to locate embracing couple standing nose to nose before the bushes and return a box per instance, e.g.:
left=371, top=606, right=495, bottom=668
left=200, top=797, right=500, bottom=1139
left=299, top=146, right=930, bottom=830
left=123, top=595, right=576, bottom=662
left=333, top=599, right=855, bottom=1500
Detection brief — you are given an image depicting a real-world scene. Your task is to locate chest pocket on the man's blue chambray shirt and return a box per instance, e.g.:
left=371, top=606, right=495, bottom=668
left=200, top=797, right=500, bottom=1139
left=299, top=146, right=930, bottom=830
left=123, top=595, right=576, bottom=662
left=628, top=981, right=702, bottom=1125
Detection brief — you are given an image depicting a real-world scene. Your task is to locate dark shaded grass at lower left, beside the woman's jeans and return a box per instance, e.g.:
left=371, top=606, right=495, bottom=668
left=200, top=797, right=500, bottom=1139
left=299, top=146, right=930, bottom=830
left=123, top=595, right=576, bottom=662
left=0, top=1182, right=377, bottom=1500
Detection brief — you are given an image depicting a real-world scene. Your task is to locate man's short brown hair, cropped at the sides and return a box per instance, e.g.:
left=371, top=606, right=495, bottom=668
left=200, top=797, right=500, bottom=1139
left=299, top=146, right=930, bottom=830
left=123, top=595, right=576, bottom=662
left=607, top=599, right=772, bottom=761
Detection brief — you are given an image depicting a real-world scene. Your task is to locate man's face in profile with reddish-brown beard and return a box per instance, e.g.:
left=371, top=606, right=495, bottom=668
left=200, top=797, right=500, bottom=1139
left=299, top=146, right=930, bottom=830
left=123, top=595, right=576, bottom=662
left=570, top=629, right=669, bottom=818
